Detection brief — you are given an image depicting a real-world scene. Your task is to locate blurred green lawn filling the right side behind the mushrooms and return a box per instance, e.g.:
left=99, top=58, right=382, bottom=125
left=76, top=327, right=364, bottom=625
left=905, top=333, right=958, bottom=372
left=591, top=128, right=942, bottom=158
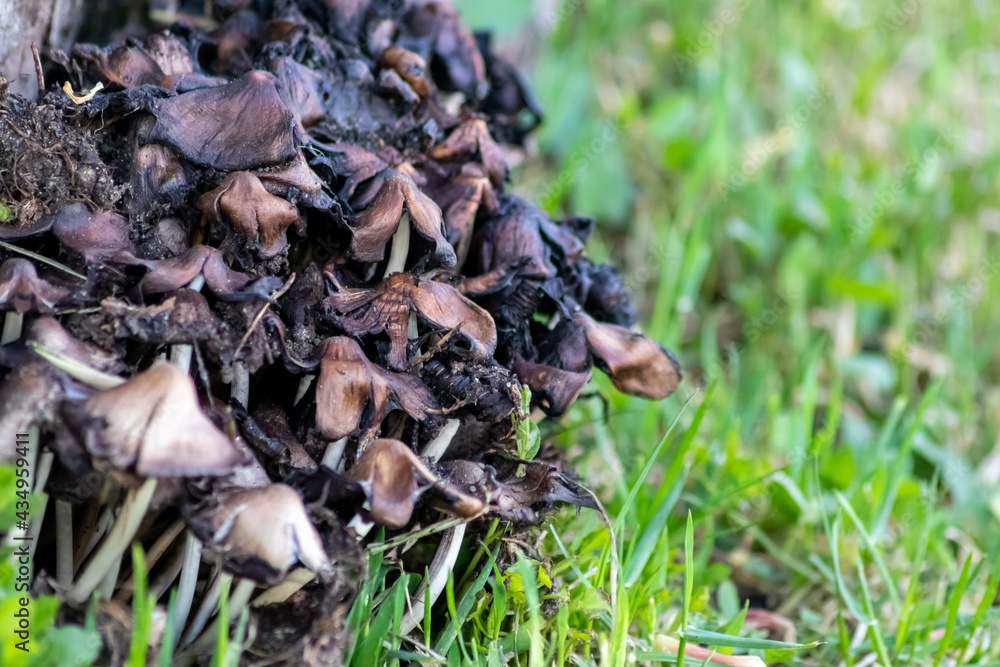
left=457, top=0, right=1000, bottom=664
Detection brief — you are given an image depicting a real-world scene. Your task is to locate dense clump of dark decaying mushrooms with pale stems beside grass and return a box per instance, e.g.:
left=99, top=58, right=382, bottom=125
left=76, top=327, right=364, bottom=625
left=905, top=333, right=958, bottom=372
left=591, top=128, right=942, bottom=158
left=0, top=0, right=680, bottom=664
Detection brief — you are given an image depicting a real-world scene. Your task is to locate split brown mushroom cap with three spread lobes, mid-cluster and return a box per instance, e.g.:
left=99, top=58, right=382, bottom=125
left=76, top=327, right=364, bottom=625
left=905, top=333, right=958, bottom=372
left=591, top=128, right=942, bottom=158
left=324, top=273, right=497, bottom=370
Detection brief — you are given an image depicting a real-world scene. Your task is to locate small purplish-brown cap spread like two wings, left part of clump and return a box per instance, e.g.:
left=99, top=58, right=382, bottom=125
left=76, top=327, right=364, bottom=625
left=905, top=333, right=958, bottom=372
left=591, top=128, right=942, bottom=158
left=139, top=245, right=250, bottom=295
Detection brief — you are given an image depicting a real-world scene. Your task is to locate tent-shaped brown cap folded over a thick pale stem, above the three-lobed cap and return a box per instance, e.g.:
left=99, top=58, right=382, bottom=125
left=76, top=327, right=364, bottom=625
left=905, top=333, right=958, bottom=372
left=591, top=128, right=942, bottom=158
left=351, top=170, right=456, bottom=267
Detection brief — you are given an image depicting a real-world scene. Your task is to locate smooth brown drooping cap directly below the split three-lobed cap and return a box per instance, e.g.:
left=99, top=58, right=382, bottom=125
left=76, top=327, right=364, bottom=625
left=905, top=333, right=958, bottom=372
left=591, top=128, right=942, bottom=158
left=316, top=336, right=438, bottom=440
